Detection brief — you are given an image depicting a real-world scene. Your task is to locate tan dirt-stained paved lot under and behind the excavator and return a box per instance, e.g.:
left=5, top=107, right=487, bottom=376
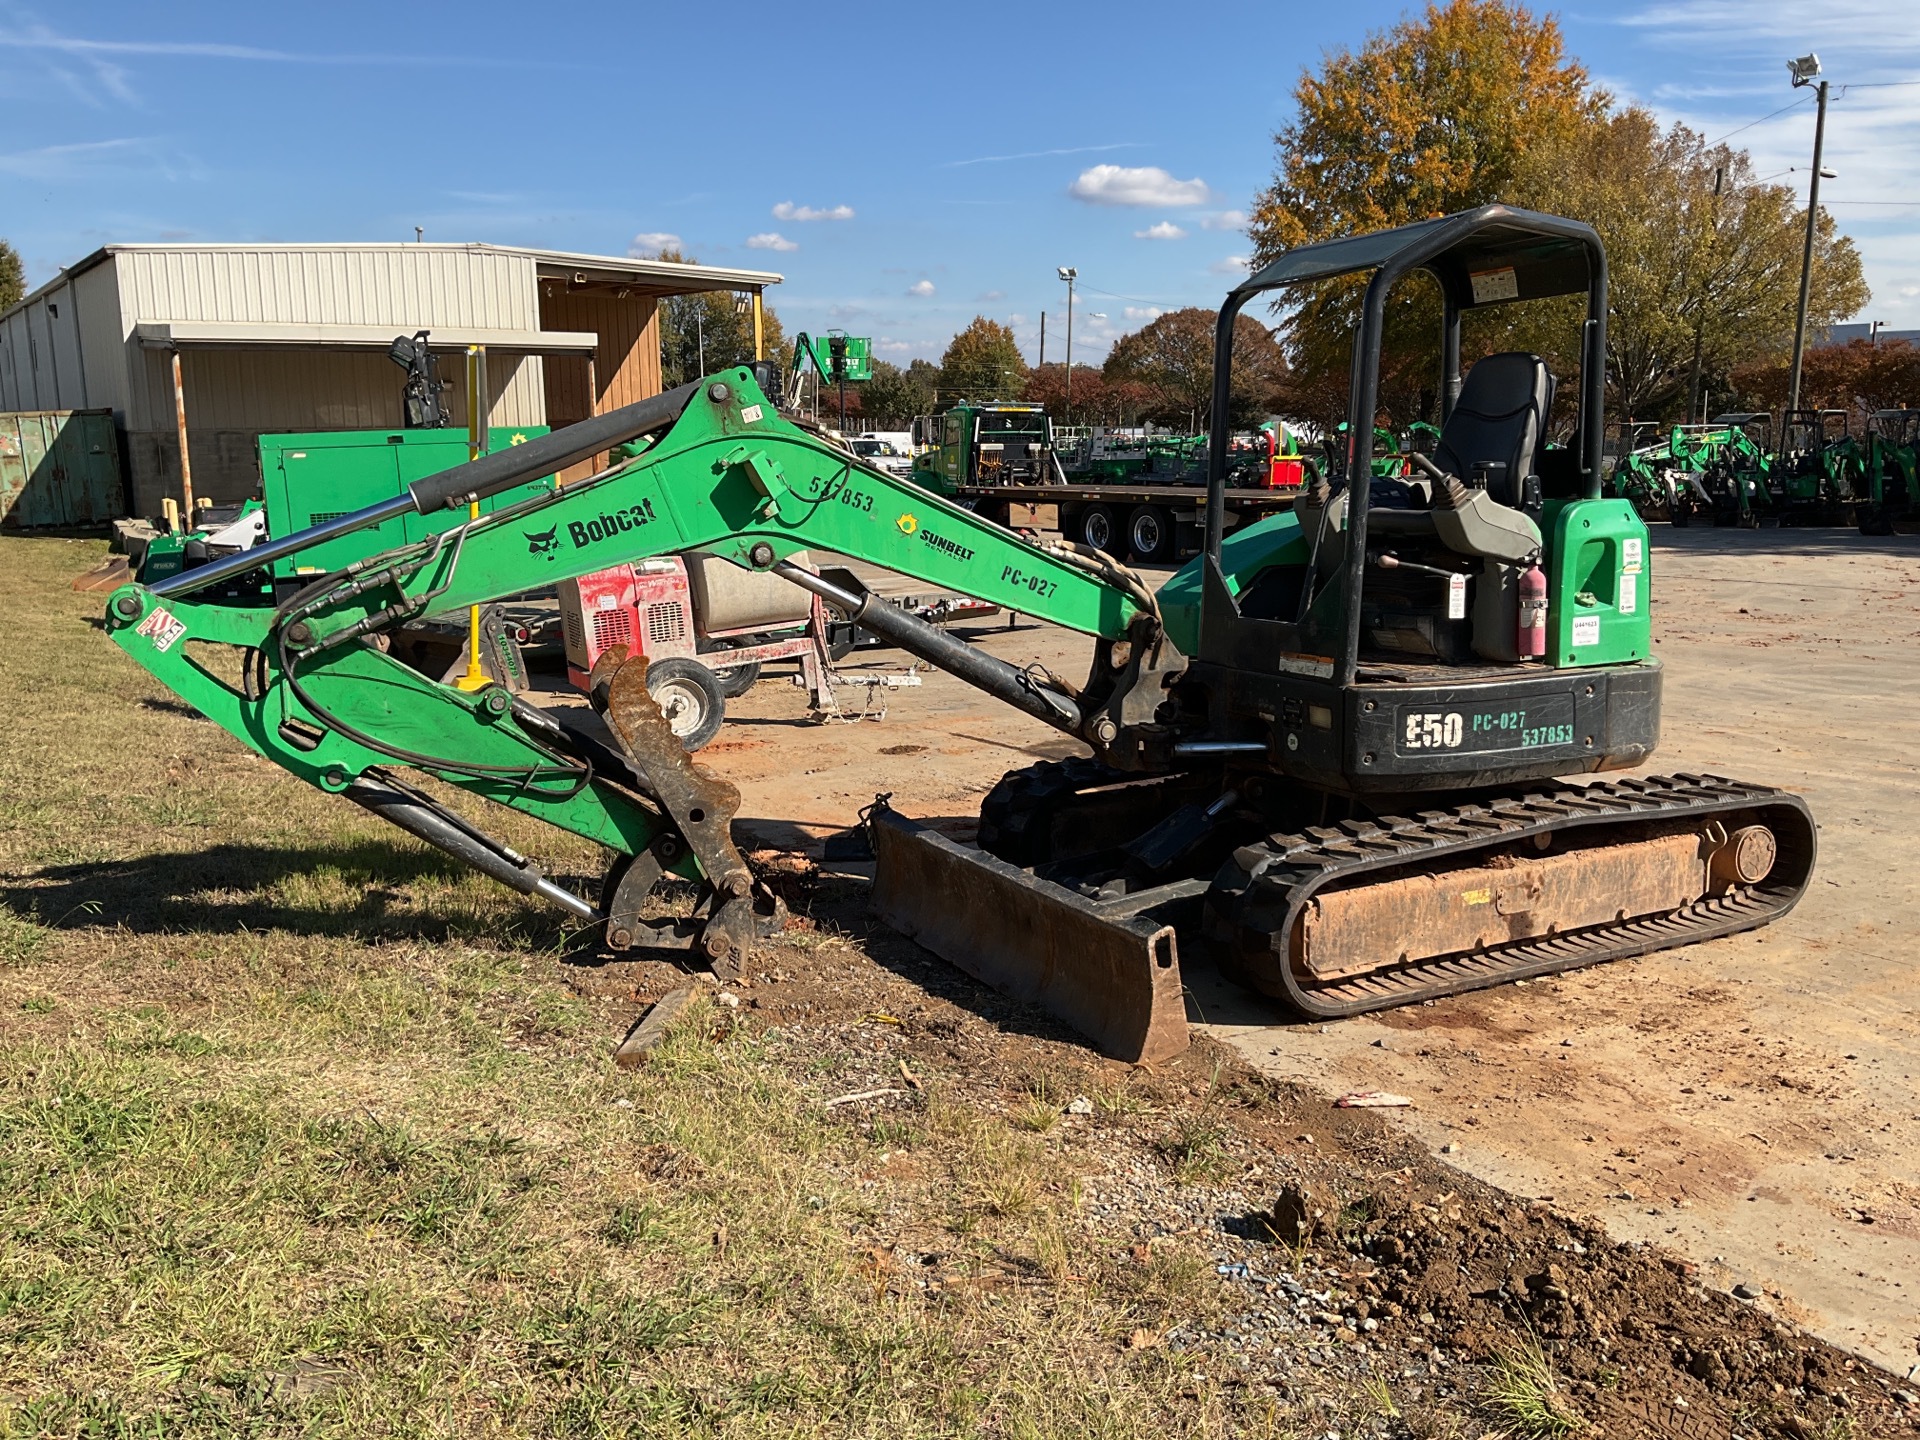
left=668, top=526, right=1920, bottom=1377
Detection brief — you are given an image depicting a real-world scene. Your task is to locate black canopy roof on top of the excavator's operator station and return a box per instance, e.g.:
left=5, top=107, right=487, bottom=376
left=1229, top=205, right=1601, bottom=309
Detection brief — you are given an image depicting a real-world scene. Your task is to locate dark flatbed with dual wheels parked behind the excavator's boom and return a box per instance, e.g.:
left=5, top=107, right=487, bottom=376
left=954, top=480, right=1300, bottom=561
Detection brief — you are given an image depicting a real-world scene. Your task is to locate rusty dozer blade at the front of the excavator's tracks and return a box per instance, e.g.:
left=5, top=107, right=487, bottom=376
left=870, top=806, right=1187, bottom=1062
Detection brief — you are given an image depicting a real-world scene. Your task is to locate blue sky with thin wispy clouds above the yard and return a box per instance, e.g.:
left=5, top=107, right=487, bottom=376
left=0, top=0, right=1920, bottom=361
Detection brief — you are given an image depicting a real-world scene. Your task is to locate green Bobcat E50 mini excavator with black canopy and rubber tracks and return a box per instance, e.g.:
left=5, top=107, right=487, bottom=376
left=108, top=205, right=1814, bottom=1060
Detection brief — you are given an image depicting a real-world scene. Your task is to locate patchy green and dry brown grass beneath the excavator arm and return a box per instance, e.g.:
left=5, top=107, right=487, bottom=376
left=0, top=538, right=1277, bottom=1440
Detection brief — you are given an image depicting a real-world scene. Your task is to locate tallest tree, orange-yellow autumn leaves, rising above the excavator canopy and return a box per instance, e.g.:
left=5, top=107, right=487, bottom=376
left=1248, top=0, right=1607, bottom=419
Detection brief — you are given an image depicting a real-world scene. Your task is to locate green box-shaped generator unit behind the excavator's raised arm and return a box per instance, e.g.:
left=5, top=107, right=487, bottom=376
left=259, top=424, right=557, bottom=588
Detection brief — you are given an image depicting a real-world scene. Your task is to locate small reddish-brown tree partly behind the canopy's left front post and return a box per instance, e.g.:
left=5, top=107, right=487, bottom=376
left=1102, top=305, right=1286, bottom=428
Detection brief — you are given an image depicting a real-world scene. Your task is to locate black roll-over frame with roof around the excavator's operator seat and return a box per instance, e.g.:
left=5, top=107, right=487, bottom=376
left=1206, top=205, right=1607, bottom=685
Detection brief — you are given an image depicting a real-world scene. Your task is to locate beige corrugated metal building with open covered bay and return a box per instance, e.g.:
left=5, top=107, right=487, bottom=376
left=0, top=244, right=781, bottom=515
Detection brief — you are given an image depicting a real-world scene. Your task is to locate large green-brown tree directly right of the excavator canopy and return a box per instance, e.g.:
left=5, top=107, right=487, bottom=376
left=1521, top=106, right=1868, bottom=419
